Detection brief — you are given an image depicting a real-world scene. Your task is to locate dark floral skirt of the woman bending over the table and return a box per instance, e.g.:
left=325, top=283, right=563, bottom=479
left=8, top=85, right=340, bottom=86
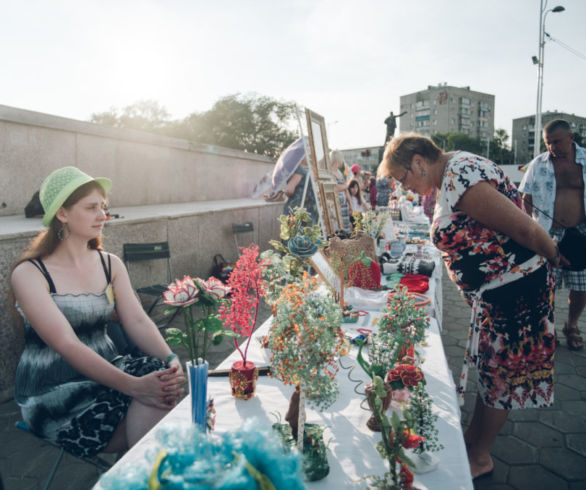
left=477, top=266, right=555, bottom=410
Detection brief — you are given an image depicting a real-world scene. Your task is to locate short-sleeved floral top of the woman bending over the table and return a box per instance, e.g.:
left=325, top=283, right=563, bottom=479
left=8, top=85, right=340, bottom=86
left=431, top=151, right=535, bottom=303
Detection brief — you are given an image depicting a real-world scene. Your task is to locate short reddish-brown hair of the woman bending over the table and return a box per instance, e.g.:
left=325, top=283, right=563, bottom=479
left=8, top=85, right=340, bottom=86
left=377, top=133, right=442, bottom=178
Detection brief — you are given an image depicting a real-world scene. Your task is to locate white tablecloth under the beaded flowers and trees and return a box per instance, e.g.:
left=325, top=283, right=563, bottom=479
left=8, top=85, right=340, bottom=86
left=97, top=262, right=473, bottom=490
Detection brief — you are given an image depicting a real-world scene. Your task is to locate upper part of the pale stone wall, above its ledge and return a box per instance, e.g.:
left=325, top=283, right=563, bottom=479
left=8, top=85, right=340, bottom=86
left=0, top=105, right=273, bottom=216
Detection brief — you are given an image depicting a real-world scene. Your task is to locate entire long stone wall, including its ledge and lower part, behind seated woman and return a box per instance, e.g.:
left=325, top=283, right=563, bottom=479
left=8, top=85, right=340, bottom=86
left=0, top=105, right=283, bottom=402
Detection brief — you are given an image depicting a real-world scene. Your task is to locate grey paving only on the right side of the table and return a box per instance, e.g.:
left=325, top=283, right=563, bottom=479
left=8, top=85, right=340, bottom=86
left=442, top=274, right=586, bottom=490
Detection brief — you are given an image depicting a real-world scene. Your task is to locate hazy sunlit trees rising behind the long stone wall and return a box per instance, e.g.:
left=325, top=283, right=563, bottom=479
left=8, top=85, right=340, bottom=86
left=90, top=94, right=298, bottom=157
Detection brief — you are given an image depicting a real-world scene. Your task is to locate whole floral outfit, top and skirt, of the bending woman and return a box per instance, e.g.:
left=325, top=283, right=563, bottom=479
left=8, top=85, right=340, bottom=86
left=431, top=152, right=555, bottom=409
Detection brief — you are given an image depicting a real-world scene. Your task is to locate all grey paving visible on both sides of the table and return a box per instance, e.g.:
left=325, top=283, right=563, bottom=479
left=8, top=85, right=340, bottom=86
left=0, top=274, right=586, bottom=490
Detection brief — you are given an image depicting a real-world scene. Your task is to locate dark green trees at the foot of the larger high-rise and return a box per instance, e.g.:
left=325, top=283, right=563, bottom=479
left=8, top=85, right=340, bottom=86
left=431, top=129, right=513, bottom=165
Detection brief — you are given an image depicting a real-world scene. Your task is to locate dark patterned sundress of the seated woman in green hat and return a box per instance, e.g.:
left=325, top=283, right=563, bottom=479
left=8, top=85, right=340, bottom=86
left=14, top=252, right=164, bottom=456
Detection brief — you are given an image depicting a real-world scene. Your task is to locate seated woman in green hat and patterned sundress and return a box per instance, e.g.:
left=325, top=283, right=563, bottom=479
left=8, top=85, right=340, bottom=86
left=11, top=167, right=185, bottom=457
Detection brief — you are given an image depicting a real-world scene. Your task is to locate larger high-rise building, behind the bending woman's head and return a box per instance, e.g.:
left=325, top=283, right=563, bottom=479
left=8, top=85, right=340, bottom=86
left=399, top=83, right=494, bottom=140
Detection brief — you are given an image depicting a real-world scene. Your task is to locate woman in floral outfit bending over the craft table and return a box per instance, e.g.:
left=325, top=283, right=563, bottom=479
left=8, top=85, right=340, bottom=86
left=379, top=133, right=563, bottom=478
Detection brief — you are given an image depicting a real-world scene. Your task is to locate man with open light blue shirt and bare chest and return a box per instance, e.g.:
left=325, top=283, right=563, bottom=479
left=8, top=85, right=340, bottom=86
left=519, top=119, right=586, bottom=350
